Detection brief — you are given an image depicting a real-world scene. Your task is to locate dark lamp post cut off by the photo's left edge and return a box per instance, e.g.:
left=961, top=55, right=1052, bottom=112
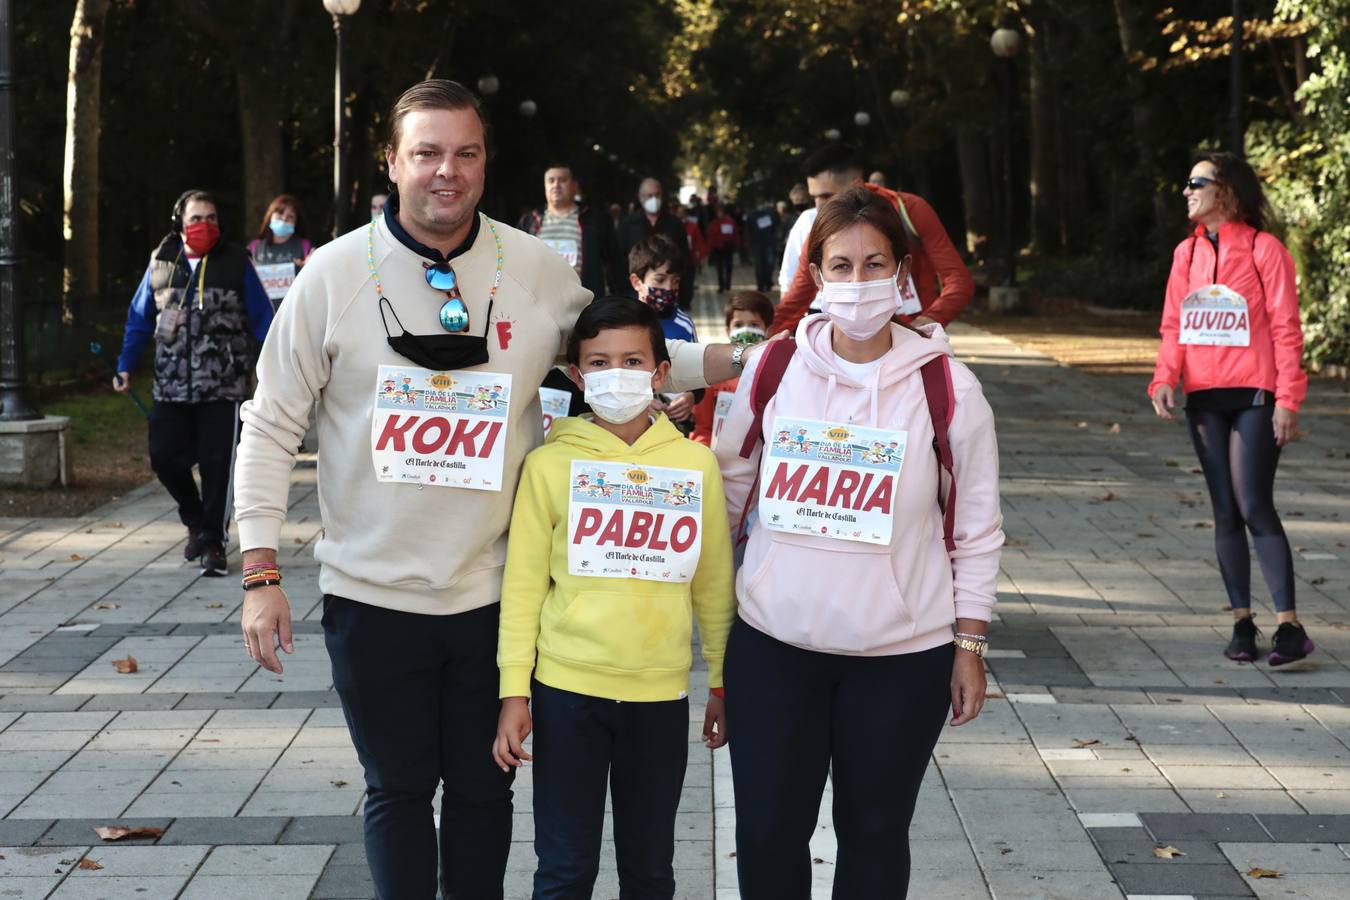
left=0, top=0, right=42, bottom=422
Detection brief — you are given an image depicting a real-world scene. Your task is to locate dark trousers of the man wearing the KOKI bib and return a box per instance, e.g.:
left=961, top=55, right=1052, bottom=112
left=324, top=595, right=514, bottom=900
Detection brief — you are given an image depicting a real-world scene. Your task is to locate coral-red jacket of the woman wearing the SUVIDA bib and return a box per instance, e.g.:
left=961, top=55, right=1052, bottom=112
left=1149, top=221, right=1308, bottom=412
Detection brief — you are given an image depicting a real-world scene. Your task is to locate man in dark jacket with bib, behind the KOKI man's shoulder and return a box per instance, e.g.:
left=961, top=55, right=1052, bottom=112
left=520, top=163, right=628, bottom=297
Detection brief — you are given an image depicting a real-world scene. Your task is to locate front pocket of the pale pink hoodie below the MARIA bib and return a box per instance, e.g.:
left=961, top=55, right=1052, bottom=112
left=745, top=534, right=914, bottom=653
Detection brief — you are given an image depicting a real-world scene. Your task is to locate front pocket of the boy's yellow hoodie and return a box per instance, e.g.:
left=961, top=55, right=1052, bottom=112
left=539, top=591, right=693, bottom=672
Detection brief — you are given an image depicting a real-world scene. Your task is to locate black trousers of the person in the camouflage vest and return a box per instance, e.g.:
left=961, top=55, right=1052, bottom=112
left=150, top=401, right=239, bottom=544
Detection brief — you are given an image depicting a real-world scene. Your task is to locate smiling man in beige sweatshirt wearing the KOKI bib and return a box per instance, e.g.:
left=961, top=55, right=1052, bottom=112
left=235, top=80, right=744, bottom=897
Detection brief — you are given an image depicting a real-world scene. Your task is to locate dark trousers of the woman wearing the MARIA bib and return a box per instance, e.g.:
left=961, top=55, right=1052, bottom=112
left=725, top=619, right=954, bottom=900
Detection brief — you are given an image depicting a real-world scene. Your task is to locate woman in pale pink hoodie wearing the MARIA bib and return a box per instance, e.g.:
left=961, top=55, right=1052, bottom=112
left=717, top=189, right=1003, bottom=900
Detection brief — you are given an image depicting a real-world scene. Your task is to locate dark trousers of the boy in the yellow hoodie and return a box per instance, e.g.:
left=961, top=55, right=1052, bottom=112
left=531, top=681, right=689, bottom=900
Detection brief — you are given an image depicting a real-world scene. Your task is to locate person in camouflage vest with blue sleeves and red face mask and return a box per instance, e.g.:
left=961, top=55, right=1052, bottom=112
left=112, top=190, right=273, bottom=576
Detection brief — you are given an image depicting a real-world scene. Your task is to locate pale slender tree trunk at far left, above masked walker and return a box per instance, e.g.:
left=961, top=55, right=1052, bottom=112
left=61, top=0, right=111, bottom=324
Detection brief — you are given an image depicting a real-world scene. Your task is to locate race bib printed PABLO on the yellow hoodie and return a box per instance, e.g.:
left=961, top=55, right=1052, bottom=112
left=567, top=460, right=703, bottom=582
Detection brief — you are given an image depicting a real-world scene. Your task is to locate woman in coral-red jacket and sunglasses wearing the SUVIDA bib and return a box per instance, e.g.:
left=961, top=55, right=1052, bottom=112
left=1149, top=152, right=1314, bottom=665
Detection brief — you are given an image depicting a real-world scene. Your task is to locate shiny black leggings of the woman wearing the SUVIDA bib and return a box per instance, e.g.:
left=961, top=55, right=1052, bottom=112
left=1185, top=405, right=1293, bottom=613
